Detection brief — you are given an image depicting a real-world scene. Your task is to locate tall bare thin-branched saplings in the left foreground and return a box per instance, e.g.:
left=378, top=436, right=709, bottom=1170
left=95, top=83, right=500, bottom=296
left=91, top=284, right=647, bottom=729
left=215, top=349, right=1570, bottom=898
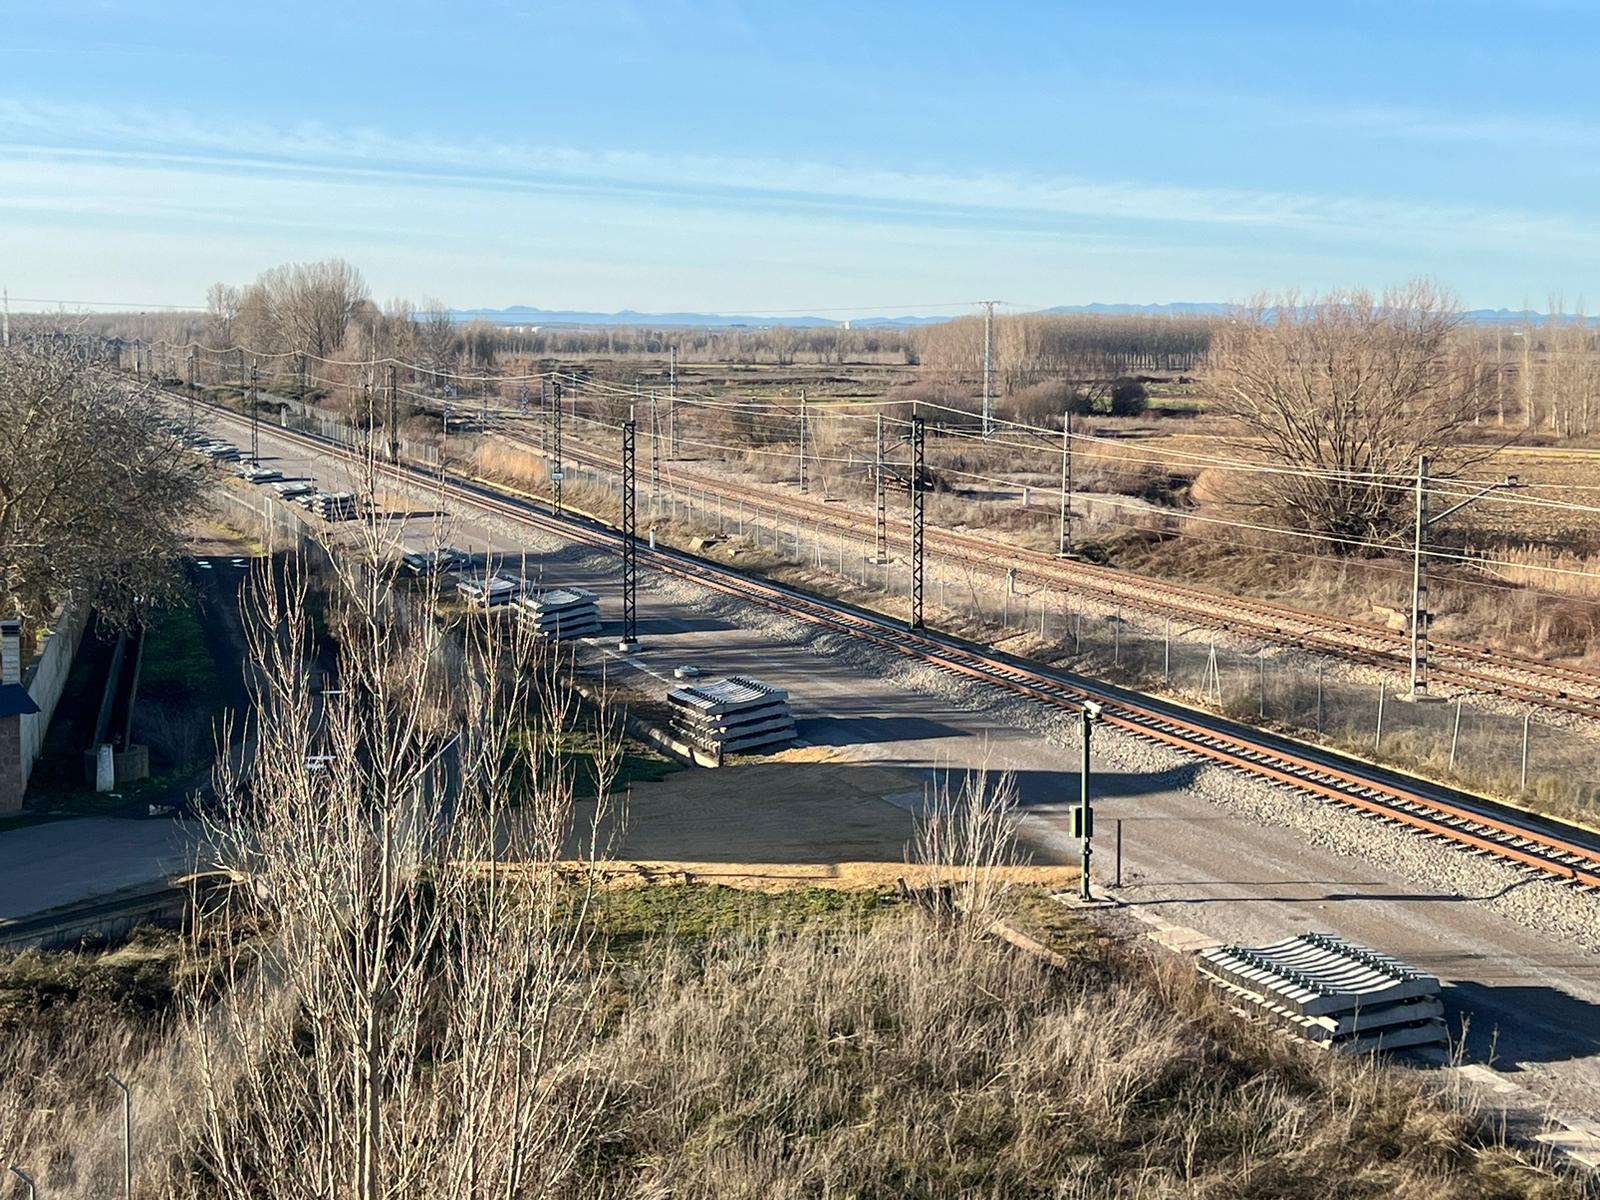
left=181, top=473, right=619, bottom=1200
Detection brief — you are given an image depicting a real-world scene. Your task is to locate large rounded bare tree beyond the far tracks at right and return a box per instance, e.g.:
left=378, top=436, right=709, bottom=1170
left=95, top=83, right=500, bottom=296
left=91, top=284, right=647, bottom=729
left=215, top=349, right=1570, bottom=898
left=1210, top=282, right=1494, bottom=544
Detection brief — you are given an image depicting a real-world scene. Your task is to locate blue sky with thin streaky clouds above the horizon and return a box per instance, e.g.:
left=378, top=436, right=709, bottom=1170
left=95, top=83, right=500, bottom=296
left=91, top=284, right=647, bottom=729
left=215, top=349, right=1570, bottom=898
left=0, top=0, right=1600, bottom=314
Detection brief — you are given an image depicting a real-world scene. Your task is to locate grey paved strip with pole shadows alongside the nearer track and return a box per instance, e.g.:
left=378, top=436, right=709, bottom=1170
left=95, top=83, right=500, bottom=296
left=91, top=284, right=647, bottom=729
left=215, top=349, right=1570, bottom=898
left=90, top=409, right=1600, bottom=1115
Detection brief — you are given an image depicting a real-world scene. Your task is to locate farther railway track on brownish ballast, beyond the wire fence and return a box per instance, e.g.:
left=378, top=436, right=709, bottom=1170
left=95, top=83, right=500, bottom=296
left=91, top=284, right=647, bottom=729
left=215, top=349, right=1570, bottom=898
left=502, top=430, right=1600, bottom=722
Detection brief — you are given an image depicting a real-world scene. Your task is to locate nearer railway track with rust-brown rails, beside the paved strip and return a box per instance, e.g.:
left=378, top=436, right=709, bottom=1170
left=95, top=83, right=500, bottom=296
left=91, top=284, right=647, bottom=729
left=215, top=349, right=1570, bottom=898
left=181, top=400, right=1600, bottom=893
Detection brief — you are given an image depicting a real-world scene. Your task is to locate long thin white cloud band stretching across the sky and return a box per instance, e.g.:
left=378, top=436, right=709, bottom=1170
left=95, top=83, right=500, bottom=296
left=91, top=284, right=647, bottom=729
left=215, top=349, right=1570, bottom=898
left=0, top=99, right=1595, bottom=250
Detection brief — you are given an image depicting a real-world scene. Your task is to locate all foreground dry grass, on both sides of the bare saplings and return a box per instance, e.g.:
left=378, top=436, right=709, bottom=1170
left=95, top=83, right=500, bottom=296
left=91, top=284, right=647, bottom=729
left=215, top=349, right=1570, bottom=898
left=0, top=885, right=1582, bottom=1200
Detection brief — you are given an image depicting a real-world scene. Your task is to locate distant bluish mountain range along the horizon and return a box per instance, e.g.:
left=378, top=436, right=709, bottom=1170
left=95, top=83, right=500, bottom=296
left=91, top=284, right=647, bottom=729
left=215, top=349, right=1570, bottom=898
left=450, top=301, right=1600, bottom=330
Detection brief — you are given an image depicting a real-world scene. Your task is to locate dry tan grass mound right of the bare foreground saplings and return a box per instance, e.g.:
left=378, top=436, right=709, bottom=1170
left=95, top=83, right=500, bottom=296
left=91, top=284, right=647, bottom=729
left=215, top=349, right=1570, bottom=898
left=579, top=909, right=1576, bottom=1198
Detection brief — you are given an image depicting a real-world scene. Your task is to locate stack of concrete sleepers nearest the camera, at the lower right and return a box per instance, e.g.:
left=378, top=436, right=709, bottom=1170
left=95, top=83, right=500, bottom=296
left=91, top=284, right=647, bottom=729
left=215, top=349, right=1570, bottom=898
left=1200, top=933, right=1445, bottom=1051
